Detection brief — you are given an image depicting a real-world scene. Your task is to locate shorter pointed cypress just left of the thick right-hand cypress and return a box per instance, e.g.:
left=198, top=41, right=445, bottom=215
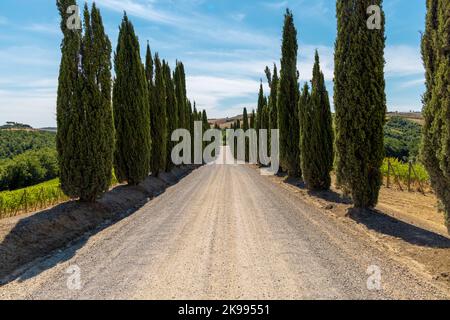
left=299, top=51, right=334, bottom=190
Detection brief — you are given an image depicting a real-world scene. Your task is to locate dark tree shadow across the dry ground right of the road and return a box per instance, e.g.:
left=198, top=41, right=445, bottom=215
left=348, top=208, right=450, bottom=249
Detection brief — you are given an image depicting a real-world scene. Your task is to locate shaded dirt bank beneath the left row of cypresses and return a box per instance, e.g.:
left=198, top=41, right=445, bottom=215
left=0, top=166, right=199, bottom=285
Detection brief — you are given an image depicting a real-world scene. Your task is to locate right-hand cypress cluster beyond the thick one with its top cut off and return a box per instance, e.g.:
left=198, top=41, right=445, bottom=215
left=256, top=10, right=334, bottom=190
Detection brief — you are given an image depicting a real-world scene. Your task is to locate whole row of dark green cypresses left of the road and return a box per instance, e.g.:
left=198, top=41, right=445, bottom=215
left=57, top=0, right=209, bottom=202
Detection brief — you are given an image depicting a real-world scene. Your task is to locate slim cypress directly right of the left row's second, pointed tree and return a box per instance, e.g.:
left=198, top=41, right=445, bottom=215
left=150, top=54, right=168, bottom=176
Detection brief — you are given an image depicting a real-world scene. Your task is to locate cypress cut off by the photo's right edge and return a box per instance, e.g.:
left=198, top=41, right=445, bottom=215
left=421, top=0, right=450, bottom=233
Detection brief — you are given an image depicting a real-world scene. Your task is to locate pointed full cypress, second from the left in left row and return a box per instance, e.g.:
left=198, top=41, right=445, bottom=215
left=113, top=14, right=151, bottom=185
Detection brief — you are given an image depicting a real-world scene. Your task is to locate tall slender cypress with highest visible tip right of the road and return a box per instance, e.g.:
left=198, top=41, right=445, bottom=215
left=277, top=9, right=301, bottom=176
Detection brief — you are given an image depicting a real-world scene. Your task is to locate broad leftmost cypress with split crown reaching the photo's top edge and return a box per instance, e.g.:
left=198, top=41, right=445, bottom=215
left=57, top=1, right=114, bottom=202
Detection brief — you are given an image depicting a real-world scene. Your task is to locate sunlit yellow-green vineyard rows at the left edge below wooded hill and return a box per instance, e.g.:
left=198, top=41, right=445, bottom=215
left=0, top=179, right=69, bottom=218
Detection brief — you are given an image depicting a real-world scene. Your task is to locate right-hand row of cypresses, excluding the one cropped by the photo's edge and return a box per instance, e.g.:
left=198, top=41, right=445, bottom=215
left=253, top=6, right=386, bottom=208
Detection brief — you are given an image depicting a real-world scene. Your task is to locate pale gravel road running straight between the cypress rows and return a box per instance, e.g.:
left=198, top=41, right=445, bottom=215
left=0, top=148, right=449, bottom=299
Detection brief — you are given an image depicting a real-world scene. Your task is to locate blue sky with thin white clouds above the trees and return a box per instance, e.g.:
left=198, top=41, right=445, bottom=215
left=0, top=0, right=425, bottom=127
